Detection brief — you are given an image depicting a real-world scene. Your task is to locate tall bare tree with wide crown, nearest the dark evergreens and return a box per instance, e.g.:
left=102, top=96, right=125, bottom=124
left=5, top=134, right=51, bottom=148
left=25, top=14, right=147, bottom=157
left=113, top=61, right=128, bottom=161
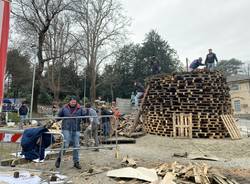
left=72, top=0, right=129, bottom=103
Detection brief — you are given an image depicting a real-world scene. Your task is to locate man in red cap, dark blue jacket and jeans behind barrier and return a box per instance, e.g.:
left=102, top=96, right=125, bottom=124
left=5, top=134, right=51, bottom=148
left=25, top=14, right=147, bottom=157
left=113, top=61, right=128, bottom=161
left=55, top=96, right=86, bottom=169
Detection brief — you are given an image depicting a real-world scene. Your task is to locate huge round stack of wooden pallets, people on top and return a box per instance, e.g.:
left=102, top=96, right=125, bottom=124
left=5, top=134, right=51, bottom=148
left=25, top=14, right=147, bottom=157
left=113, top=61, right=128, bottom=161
left=143, top=71, right=232, bottom=138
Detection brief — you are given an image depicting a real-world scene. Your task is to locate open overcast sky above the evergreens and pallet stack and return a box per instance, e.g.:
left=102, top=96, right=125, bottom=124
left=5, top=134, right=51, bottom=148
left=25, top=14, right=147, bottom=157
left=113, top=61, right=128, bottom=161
left=120, top=0, right=250, bottom=62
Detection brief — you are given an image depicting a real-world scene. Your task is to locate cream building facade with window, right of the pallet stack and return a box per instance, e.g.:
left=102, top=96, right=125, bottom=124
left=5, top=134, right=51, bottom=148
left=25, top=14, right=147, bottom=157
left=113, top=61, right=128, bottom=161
left=227, top=75, right=250, bottom=116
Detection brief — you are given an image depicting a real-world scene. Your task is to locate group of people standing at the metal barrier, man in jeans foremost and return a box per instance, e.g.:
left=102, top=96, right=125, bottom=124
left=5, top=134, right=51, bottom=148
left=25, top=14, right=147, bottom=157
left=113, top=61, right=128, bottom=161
left=55, top=96, right=120, bottom=169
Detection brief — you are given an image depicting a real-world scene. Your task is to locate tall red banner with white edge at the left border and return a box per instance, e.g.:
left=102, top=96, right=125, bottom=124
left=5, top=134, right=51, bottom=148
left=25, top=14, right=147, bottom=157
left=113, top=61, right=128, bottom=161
left=0, top=0, right=10, bottom=112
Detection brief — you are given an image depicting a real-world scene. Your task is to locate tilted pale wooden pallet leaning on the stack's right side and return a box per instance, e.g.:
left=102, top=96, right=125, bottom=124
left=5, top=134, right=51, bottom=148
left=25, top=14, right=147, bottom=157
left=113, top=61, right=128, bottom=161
left=221, top=115, right=241, bottom=139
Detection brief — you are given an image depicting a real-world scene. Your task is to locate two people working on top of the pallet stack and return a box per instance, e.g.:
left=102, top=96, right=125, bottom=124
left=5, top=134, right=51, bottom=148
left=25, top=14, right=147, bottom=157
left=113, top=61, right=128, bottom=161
left=189, top=49, right=218, bottom=71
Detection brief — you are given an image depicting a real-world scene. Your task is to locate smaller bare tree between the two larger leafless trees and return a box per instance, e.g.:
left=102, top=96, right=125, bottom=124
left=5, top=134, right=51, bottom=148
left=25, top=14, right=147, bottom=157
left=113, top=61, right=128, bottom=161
left=44, top=15, right=78, bottom=101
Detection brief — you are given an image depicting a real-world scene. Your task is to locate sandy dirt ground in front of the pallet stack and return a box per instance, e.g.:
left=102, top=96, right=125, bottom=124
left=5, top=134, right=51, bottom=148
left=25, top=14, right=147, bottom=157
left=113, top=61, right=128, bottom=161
left=5, top=135, right=250, bottom=184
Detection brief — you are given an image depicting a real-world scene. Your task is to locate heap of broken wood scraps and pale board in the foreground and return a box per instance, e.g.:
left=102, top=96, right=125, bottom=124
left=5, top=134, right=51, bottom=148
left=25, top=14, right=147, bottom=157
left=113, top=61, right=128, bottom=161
left=107, top=162, right=238, bottom=184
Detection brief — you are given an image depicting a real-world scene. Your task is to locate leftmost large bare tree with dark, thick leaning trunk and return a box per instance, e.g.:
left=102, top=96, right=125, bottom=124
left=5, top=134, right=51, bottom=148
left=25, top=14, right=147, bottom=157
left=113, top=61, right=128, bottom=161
left=12, top=0, right=69, bottom=112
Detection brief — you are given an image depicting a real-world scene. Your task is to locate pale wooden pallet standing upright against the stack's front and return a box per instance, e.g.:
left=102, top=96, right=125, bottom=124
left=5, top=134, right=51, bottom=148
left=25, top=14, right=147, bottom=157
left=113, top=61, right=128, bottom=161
left=173, top=113, right=193, bottom=138
